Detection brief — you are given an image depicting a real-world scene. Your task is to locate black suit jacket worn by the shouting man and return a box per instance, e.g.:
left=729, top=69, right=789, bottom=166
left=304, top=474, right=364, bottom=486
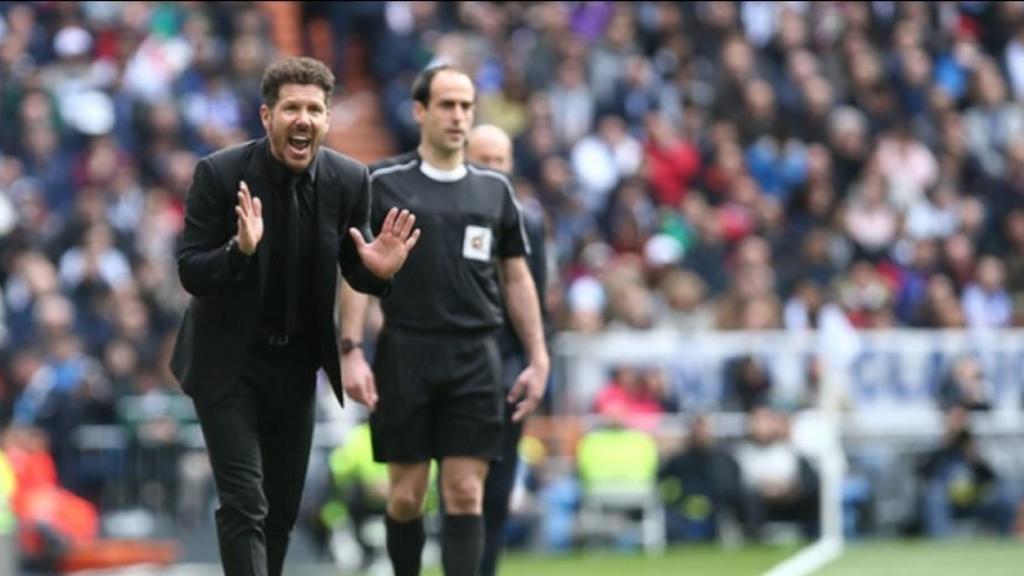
left=171, top=138, right=390, bottom=405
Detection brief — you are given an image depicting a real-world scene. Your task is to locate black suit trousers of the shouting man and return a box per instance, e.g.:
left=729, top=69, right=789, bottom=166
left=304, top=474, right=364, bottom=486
left=196, top=336, right=316, bottom=576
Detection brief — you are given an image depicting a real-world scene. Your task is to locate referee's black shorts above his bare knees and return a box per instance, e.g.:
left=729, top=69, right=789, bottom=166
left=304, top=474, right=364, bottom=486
left=370, top=328, right=505, bottom=462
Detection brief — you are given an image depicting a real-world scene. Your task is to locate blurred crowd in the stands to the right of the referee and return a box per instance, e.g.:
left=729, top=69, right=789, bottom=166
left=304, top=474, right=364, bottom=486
left=372, top=2, right=1024, bottom=331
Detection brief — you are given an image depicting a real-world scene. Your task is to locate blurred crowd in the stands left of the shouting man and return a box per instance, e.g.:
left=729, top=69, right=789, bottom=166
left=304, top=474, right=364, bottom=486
left=0, top=2, right=273, bottom=501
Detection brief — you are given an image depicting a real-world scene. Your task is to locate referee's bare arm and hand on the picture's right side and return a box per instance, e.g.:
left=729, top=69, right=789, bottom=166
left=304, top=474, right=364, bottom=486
left=501, top=256, right=551, bottom=421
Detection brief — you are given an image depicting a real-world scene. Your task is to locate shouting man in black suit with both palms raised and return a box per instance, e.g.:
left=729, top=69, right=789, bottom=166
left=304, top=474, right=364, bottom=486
left=171, top=57, right=419, bottom=576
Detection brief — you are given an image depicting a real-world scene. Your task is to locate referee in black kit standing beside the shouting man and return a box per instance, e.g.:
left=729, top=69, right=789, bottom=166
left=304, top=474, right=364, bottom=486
left=341, top=65, right=549, bottom=576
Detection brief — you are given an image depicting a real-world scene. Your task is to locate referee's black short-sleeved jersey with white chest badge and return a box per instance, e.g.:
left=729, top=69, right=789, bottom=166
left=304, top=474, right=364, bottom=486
left=370, top=152, right=529, bottom=333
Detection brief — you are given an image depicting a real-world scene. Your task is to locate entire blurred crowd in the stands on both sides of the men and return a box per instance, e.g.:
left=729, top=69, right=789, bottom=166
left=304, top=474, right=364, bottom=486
left=6, top=2, right=1024, bottom=421
